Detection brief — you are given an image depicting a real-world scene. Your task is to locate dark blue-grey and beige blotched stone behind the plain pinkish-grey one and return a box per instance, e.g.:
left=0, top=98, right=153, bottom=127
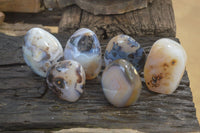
left=104, top=34, right=146, bottom=71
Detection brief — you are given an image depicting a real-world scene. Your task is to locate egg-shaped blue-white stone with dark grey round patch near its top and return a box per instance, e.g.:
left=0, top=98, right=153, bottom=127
left=64, top=28, right=102, bottom=79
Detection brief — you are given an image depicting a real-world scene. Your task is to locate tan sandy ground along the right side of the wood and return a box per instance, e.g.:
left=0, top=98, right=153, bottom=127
left=172, top=0, right=200, bottom=122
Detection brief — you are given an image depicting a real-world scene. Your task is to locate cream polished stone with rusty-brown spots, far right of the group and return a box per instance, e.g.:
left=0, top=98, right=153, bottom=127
left=144, top=38, right=187, bottom=94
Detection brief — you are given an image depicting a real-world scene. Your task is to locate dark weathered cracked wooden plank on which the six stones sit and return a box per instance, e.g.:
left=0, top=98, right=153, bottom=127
left=0, top=34, right=199, bottom=132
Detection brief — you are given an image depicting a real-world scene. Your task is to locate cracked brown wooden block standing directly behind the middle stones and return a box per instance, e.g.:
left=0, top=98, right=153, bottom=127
left=59, top=0, right=176, bottom=39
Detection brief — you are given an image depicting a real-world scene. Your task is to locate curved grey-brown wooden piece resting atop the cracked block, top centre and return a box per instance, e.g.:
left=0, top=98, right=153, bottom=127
left=76, top=0, right=148, bottom=15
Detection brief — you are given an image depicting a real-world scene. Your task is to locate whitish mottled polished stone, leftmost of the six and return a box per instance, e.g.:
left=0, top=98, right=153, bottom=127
left=22, top=28, right=63, bottom=77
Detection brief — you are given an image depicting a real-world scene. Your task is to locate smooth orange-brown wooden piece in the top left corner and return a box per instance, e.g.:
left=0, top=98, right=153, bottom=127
left=0, top=0, right=42, bottom=13
